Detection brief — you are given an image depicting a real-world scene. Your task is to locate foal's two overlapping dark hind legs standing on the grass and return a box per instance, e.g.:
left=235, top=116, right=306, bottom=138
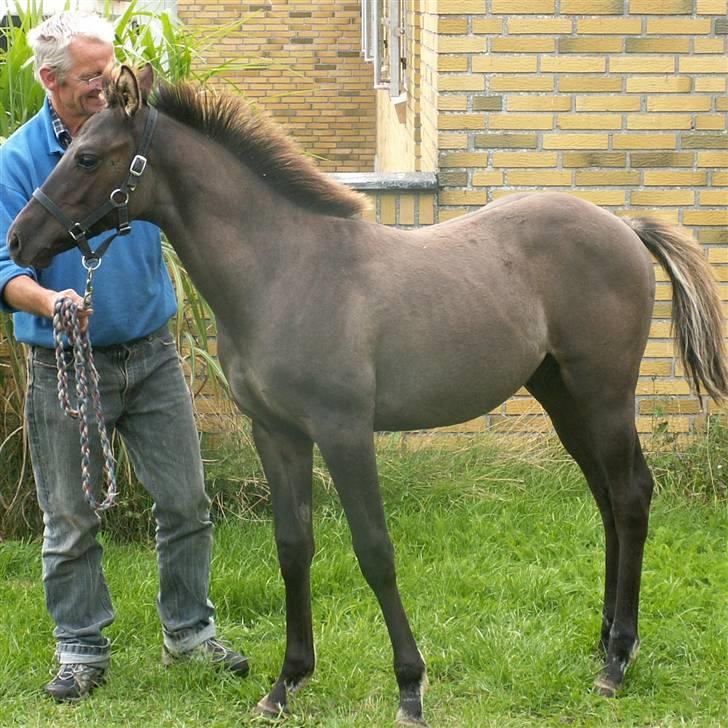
left=527, top=357, right=652, bottom=695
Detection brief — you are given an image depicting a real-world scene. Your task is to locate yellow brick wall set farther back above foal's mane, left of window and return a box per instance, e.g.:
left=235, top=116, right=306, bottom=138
left=177, top=0, right=376, bottom=172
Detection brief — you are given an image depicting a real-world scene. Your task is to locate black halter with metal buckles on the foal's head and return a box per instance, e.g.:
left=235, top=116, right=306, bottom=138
left=33, top=106, right=159, bottom=270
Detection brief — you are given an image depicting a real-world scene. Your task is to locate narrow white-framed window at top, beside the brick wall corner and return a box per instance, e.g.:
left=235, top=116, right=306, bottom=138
left=361, top=0, right=407, bottom=98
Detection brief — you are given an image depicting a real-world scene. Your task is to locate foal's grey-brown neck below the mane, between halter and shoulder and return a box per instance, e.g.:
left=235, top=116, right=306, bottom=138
left=152, top=117, right=319, bottom=316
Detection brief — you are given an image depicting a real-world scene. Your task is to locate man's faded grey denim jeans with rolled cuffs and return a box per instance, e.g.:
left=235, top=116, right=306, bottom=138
left=26, top=327, right=215, bottom=666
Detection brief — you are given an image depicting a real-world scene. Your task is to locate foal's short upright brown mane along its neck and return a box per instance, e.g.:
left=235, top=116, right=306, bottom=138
left=144, top=83, right=368, bottom=217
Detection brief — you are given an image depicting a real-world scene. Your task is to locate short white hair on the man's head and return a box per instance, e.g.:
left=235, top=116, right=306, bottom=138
left=28, top=11, right=114, bottom=81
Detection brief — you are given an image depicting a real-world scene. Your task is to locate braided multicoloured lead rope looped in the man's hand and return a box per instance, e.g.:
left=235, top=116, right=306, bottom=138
left=53, top=258, right=118, bottom=511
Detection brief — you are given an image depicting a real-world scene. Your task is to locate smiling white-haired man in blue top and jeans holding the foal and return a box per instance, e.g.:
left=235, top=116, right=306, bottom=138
left=0, top=12, right=248, bottom=701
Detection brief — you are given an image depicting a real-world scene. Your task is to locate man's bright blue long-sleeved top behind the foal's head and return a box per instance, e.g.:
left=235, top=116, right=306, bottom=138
left=0, top=101, right=177, bottom=348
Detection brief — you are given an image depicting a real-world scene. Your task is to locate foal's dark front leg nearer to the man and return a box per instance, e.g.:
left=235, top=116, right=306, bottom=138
left=253, top=423, right=315, bottom=716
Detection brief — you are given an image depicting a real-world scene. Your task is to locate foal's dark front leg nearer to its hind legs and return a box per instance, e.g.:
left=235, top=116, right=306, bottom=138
left=317, top=421, right=427, bottom=726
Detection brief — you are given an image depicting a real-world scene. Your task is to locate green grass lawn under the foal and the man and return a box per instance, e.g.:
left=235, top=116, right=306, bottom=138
left=0, top=439, right=728, bottom=728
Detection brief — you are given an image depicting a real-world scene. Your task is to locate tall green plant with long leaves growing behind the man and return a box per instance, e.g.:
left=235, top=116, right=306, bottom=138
left=0, top=0, right=253, bottom=540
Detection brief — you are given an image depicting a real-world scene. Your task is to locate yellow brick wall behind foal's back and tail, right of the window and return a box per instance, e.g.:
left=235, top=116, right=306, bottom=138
left=423, top=0, right=728, bottom=432
